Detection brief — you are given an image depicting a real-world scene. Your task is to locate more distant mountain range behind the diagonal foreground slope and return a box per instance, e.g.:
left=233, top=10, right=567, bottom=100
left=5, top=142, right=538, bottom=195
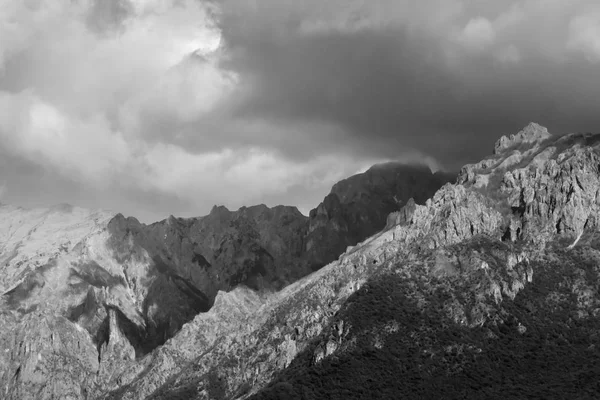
left=0, top=164, right=450, bottom=399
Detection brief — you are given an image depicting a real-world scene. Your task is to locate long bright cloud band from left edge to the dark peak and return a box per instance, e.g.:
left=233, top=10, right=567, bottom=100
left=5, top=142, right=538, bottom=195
left=0, top=86, right=384, bottom=211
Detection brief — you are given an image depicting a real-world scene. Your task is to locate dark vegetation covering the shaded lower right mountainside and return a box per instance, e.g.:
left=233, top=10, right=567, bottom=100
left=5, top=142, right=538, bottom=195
left=252, top=238, right=600, bottom=400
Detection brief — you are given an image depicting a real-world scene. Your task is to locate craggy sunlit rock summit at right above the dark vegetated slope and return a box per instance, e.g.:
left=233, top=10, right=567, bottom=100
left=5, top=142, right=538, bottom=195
left=394, top=125, right=600, bottom=253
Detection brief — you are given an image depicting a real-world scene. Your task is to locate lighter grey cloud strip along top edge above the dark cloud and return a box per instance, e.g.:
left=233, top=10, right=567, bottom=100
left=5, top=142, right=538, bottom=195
left=230, top=0, right=598, bottom=64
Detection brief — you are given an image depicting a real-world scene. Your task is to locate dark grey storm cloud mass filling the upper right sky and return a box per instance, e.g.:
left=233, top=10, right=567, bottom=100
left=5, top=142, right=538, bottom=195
left=214, top=0, right=600, bottom=169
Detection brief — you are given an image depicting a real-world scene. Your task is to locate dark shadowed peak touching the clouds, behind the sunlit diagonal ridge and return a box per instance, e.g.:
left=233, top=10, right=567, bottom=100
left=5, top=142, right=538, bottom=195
left=306, top=163, right=454, bottom=269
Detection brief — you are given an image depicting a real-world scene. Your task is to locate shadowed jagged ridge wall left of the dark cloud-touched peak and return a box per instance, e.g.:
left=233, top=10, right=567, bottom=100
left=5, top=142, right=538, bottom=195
left=102, top=205, right=306, bottom=354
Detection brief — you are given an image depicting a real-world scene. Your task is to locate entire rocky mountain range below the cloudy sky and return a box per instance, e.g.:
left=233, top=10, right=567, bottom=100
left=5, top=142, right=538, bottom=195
left=0, top=124, right=600, bottom=399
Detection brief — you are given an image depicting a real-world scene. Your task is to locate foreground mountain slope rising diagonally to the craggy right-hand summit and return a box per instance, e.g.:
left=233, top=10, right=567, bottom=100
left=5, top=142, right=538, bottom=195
left=103, top=124, right=600, bottom=399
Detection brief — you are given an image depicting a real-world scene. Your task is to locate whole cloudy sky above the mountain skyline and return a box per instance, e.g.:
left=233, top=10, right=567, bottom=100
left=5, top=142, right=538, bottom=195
left=0, top=0, right=600, bottom=221
